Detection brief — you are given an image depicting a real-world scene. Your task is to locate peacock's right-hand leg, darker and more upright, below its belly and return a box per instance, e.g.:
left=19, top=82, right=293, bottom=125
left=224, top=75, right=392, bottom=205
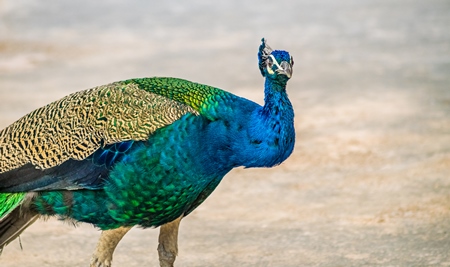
left=158, top=216, right=183, bottom=267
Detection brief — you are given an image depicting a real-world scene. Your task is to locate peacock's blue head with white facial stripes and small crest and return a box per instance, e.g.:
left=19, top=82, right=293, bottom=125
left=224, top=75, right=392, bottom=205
left=258, top=38, right=294, bottom=83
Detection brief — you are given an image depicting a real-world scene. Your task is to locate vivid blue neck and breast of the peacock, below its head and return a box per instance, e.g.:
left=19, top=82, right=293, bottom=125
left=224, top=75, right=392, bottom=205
left=188, top=76, right=295, bottom=173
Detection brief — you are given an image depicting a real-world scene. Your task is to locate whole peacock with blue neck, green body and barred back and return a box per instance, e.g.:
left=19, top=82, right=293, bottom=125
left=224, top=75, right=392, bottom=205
left=0, top=38, right=295, bottom=267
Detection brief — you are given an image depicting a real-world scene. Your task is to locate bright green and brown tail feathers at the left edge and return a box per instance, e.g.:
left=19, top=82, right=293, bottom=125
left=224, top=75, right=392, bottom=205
left=0, top=193, right=39, bottom=252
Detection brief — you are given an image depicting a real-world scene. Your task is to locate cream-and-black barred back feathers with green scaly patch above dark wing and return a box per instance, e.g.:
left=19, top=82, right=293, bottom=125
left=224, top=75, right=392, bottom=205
left=0, top=78, right=227, bottom=173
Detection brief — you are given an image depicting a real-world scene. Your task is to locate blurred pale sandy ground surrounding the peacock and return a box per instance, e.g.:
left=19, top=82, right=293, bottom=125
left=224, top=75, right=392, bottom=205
left=0, top=0, right=450, bottom=267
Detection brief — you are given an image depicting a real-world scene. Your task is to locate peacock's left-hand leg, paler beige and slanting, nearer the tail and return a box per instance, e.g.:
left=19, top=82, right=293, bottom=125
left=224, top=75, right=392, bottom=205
left=90, top=227, right=131, bottom=267
